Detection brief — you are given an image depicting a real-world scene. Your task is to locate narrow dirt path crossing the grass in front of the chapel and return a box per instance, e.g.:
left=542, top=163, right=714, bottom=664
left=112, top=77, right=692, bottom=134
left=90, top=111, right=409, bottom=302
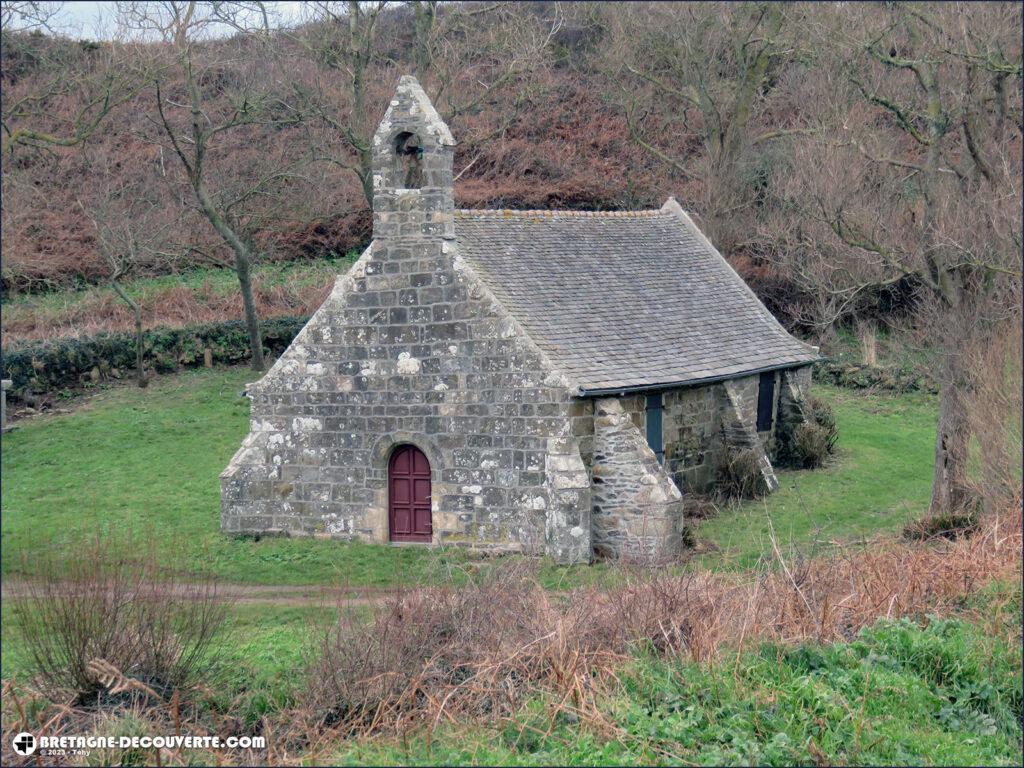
left=0, top=579, right=390, bottom=607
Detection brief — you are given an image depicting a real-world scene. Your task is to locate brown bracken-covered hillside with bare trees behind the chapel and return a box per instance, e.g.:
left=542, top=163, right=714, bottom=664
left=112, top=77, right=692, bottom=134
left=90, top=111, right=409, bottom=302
left=6, top=2, right=1021, bottom=348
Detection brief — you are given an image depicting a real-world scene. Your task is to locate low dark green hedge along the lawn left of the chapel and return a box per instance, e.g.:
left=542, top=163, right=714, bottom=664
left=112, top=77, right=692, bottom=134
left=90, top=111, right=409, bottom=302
left=0, top=316, right=308, bottom=397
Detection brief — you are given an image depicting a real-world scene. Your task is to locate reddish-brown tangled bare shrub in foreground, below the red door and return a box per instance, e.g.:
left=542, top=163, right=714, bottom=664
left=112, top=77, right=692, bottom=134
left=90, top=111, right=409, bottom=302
left=304, top=563, right=552, bottom=727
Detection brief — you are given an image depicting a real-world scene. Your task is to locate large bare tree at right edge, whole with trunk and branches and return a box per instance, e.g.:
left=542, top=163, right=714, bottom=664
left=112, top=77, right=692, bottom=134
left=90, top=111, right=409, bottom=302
left=774, top=4, right=1022, bottom=513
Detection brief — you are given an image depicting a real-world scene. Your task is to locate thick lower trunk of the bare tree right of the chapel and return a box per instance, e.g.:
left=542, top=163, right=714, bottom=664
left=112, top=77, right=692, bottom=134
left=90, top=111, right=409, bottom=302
left=929, top=380, right=971, bottom=515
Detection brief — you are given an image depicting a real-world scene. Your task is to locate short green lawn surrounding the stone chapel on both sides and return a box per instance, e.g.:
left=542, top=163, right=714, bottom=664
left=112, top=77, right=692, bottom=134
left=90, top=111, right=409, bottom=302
left=2, top=368, right=935, bottom=587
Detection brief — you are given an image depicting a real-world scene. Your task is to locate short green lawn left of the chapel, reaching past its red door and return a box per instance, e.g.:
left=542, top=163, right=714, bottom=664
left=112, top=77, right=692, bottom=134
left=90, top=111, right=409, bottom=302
left=2, top=369, right=481, bottom=586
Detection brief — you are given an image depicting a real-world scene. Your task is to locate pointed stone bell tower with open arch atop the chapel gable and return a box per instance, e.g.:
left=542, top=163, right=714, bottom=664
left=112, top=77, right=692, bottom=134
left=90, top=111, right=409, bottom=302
left=374, top=75, right=455, bottom=243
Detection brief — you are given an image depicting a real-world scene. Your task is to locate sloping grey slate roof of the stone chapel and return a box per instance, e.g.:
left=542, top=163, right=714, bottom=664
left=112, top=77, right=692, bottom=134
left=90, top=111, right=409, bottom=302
left=455, top=200, right=818, bottom=394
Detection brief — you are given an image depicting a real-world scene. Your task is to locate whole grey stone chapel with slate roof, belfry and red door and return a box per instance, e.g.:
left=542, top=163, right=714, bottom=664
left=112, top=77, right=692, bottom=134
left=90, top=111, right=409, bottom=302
left=221, top=77, right=817, bottom=562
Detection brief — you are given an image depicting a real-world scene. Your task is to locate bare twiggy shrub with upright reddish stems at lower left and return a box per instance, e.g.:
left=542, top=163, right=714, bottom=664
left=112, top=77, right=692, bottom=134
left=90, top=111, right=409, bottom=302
left=13, top=540, right=227, bottom=705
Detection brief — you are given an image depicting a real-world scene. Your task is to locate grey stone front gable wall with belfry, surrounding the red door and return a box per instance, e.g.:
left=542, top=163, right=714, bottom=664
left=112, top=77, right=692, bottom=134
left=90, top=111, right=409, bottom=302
left=221, top=78, right=591, bottom=561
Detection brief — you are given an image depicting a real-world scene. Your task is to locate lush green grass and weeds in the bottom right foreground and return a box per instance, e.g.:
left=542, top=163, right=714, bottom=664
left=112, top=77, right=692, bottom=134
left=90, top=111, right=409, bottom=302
left=335, top=585, right=1022, bottom=765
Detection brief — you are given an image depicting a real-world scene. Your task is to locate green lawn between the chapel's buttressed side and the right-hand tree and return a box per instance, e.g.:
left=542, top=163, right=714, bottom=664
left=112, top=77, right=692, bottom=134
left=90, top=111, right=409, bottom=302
left=696, top=385, right=937, bottom=568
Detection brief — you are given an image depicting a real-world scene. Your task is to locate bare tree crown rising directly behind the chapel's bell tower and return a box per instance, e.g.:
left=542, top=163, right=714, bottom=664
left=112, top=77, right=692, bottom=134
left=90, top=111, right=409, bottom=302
left=293, top=0, right=560, bottom=208
